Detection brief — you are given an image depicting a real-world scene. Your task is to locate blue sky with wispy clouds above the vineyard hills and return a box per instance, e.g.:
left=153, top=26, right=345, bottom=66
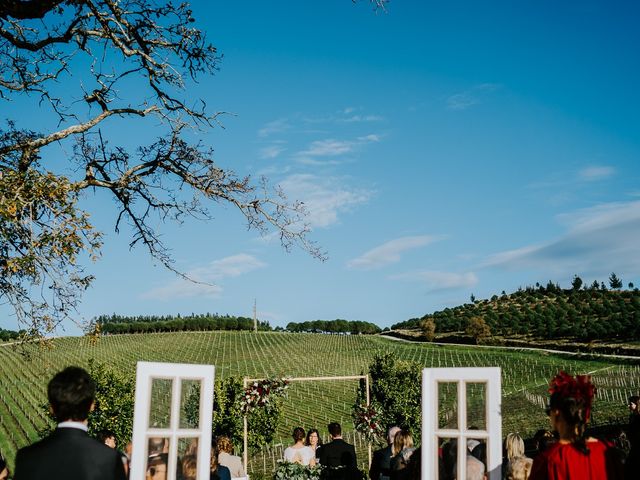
left=0, top=0, right=640, bottom=334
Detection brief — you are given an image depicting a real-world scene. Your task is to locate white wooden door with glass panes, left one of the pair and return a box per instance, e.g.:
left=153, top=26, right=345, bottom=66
left=130, top=362, right=215, bottom=480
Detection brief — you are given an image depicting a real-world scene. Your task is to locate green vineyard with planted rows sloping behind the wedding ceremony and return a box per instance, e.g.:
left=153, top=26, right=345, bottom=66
left=0, top=332, right=640, bottom=471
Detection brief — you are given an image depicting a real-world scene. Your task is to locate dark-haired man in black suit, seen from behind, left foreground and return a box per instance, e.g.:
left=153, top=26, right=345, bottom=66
left=13, top=367, right=126, bottom=480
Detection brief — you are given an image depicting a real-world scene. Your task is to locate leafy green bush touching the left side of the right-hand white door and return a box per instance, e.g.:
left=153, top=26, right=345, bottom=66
left=362, top=353, right=421, bottom=436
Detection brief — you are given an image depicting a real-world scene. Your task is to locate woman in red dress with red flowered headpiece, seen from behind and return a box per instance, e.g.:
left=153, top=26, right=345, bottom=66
left=529, top=372, right=622, bottom=480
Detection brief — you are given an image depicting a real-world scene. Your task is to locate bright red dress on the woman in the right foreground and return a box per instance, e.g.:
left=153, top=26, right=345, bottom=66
left=529, top=440, right=622, bottom=480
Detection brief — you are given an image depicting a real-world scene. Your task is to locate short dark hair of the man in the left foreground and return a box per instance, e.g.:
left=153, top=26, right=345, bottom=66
left=47, top=367, right=96, bottom=422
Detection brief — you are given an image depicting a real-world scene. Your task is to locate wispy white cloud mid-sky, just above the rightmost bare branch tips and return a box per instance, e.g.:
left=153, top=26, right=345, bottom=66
left=280, top=174, right=373, bottom=228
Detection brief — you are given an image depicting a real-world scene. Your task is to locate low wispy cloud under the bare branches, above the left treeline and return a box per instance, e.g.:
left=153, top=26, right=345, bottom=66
left=142, top=253, right=266, bottom=300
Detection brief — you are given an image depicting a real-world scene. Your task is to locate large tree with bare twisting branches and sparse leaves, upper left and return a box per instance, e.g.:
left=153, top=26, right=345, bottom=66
left=0, top=0, right=386, bottom=334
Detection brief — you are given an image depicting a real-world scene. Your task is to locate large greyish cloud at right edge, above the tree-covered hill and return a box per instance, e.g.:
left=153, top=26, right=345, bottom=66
left=484, top=201, right=640, bottom=278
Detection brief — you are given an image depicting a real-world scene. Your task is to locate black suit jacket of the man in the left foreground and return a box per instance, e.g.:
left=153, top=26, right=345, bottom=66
left=13, top=428, right=126, bottom=480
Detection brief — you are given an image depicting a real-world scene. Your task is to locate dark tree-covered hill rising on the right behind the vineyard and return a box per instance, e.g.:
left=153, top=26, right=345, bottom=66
left=391, top=274, right=640, bottom=341
